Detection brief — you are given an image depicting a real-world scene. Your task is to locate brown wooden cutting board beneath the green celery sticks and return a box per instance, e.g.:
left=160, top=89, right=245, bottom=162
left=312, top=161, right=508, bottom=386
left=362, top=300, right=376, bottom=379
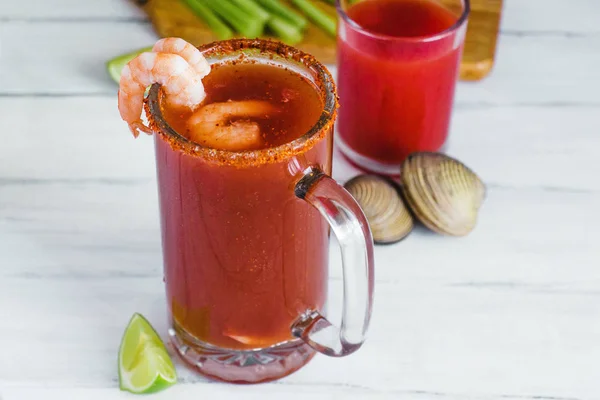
left=138, top=0, right=503, bottom=80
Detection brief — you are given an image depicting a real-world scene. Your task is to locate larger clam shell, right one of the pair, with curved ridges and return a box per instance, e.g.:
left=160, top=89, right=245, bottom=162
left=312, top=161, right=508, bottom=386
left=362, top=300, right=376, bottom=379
left=400, top=152, right=486, bottom=236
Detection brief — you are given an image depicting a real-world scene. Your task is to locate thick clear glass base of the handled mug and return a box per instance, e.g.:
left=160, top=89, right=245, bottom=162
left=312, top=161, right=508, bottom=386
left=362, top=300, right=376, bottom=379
left=169, top=320, right=315, bottom=383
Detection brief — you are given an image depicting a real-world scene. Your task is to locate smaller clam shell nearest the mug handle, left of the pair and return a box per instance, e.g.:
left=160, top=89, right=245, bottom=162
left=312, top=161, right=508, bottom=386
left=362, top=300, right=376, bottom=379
left=344, top=175, right=413, bottom=244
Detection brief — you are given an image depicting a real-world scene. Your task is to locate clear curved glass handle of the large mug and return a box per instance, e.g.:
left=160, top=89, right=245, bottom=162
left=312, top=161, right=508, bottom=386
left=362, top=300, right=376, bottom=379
left=292, top=167, right=374, bottom=357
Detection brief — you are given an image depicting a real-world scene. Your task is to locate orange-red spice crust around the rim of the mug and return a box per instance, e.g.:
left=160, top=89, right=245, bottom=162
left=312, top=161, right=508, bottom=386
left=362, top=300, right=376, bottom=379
left=144, top=39, right=338, bottom=166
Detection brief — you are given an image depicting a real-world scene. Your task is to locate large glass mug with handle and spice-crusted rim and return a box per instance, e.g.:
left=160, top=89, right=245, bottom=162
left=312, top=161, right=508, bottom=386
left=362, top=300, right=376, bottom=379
left=146, top=39, right=373, bottom=383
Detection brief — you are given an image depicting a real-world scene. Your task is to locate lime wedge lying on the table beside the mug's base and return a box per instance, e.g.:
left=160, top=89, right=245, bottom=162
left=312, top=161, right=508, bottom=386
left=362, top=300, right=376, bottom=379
left=119, top=313, right=177, bottom=393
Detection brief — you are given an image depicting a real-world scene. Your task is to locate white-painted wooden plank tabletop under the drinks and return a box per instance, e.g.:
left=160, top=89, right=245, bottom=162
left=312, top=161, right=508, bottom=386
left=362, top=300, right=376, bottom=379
left=0, top=0, right=600, bottom=400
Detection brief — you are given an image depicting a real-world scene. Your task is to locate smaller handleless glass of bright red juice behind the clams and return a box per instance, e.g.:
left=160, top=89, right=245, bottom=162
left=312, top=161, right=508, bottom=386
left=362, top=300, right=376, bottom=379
left=336, top=0, right=469, bottom=175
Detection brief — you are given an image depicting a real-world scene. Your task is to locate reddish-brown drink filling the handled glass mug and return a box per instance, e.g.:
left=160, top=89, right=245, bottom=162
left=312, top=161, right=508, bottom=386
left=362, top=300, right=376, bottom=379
left=156, top=63, right=331, bottom=350
